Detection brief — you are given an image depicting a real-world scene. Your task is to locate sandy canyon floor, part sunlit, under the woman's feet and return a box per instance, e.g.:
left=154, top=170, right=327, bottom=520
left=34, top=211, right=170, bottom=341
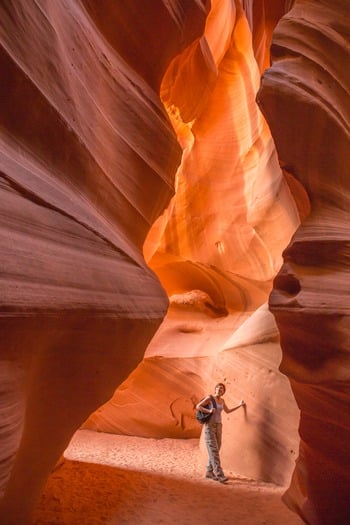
left=34, top=430, right=303, bottom=525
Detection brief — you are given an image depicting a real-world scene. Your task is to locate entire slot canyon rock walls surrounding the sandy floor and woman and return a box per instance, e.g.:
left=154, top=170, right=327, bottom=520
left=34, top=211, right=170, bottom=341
left=0, top=0, right=350, bottom=525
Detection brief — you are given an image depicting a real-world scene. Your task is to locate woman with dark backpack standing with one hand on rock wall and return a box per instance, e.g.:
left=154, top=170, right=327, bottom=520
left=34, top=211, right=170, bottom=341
left=196, top=383, right=245, bottom=483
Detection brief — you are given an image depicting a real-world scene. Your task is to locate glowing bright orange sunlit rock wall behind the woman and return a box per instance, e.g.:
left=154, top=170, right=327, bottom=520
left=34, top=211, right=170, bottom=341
left=84, top=1, right=300, bottom=484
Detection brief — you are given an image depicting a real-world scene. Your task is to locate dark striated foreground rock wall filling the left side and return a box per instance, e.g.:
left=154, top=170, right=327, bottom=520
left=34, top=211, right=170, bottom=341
left=0, top=0, right=207, bottom=525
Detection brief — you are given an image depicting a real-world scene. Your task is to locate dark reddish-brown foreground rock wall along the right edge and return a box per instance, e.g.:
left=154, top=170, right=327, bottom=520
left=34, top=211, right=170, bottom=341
left=259, top=0, right=350, bottom=525
